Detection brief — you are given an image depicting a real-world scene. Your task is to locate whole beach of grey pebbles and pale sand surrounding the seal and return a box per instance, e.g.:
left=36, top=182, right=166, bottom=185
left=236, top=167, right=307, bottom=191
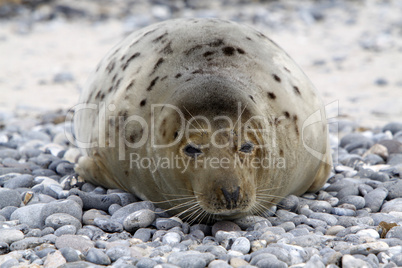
left=0, top=0, right=402, bottom=268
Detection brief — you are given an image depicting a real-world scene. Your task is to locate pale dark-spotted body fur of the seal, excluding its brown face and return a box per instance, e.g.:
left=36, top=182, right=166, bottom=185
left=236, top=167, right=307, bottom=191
left=75, top=19, right=331, bottom=221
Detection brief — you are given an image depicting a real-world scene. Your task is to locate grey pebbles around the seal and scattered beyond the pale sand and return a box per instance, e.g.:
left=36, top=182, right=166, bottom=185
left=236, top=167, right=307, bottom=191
left=0, top=1, right=402, bottom=268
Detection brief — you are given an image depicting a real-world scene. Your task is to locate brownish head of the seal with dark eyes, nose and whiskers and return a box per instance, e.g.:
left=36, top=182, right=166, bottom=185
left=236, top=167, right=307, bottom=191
left=154, top=76, right=276, bottom=220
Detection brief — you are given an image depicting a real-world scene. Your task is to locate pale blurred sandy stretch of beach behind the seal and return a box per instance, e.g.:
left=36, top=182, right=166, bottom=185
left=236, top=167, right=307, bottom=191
left=0, top=0, right=402, bottom=127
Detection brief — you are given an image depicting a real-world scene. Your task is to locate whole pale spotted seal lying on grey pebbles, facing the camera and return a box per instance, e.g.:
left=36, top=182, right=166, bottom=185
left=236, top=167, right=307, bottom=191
left=74, top=19, right=332, bottom=222
